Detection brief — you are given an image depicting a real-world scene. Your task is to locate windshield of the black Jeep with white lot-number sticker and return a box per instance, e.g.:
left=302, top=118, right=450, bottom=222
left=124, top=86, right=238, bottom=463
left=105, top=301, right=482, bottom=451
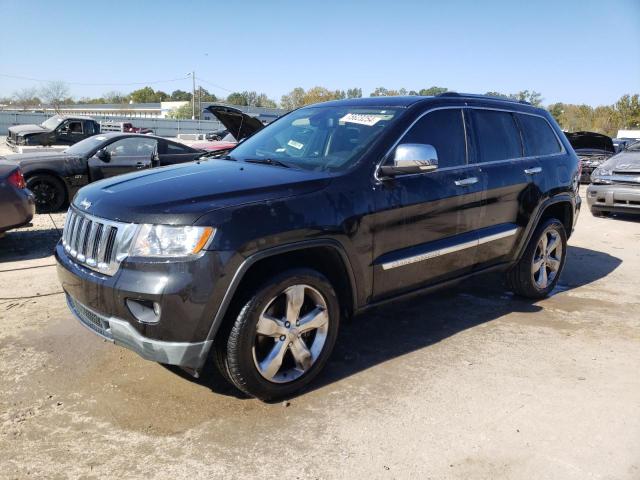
left=230, top=106, right=400, bottom=171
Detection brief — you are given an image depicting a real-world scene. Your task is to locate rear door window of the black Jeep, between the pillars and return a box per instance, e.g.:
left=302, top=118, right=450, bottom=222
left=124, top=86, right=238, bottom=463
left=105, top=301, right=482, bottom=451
left=470, top=109, right=522, bottom=163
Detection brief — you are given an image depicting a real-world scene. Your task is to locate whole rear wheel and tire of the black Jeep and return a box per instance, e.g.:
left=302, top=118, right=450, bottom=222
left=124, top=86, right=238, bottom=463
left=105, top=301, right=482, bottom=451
left=506, top=218, right=567, bottom=299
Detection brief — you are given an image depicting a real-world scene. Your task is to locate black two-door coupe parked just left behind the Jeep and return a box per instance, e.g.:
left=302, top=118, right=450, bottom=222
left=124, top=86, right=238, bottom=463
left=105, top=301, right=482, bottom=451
left=7, top=133, right=202, bottom=212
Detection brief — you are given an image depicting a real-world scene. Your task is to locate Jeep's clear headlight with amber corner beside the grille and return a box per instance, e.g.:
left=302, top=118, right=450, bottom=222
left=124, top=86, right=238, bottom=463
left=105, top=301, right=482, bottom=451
left=129, top=225, right=215, bottom=257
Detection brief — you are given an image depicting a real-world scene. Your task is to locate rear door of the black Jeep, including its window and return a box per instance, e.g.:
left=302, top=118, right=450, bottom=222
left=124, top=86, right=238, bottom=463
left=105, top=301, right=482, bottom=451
left=467, top=108, right=540, bottom=269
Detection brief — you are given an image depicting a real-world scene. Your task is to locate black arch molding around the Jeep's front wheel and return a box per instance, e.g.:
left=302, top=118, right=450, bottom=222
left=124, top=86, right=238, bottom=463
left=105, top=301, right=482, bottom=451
left=193, top=238, right=358, bottom=377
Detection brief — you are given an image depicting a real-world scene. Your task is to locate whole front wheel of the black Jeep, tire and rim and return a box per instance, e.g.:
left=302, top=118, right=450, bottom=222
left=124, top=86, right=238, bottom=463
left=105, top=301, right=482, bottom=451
left=215, top=269, right=340, bottom=400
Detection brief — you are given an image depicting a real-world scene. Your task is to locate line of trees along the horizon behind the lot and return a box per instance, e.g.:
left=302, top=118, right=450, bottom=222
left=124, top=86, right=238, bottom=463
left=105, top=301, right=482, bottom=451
left=0, top=81, right=640, bottom=136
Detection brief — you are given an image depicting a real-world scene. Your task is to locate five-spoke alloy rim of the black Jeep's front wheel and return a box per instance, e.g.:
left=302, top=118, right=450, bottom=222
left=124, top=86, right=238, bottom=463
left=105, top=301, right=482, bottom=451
left=253, top=284, right=330, bottom=383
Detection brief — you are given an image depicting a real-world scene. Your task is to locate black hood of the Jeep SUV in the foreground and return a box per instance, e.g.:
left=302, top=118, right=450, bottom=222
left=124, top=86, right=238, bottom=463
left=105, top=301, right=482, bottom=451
left=73, top=160, right=330, bottom=225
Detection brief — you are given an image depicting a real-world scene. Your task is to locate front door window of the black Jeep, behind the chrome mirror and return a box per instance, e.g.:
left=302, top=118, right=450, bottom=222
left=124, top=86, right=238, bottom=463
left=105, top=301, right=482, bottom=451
left=400, top=108, right=467, bottom=168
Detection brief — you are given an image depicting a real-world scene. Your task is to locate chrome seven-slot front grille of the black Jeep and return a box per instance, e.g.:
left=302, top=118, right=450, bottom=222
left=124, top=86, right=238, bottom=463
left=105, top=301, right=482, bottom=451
left=62, top=207, right=136, bottom=275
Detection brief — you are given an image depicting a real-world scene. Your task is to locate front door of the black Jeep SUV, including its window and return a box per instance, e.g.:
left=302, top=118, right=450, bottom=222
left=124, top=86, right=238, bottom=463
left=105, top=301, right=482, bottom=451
left=373, top=108, right=481, bottom=300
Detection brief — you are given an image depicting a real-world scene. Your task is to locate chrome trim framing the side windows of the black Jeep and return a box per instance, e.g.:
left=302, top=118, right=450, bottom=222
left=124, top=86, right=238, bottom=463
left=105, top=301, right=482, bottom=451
left=373, top=105, right=567, bottom=183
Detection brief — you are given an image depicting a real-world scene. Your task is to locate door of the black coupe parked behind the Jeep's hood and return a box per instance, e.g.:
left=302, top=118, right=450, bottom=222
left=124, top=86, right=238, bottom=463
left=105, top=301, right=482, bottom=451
left=89, top=136, right=158, bottom=182
